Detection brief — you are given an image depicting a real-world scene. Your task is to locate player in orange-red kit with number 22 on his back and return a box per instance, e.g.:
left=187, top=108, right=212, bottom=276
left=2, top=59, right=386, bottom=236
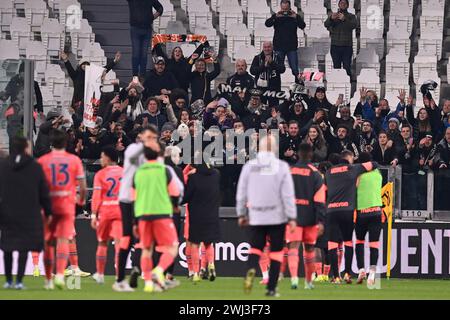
left=91, top=146, right=123, bottom=284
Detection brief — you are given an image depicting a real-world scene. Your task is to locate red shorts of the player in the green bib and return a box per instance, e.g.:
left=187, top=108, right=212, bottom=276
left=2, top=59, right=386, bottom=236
left=139, top=218, right=178, bottom=248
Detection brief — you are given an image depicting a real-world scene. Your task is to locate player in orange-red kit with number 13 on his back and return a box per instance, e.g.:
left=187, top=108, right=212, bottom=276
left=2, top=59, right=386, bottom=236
left=38, top=130, right=86, bottom=290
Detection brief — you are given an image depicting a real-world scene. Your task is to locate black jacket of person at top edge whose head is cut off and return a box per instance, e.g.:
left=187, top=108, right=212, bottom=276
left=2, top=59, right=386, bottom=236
left=127, top=0, right=164, bottom=29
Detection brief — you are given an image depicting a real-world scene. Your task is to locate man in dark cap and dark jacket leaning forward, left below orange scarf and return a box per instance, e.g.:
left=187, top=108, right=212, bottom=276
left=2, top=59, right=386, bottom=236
left=143, top=56, right=178, bottom=100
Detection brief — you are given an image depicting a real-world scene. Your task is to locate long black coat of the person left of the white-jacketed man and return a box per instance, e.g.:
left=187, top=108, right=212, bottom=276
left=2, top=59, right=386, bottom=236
left=183, top=165, right=220, bottom=243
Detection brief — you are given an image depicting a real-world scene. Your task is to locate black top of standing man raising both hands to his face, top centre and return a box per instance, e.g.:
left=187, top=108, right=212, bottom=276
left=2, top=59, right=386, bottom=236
left=266, top=13, right=306, bottom=51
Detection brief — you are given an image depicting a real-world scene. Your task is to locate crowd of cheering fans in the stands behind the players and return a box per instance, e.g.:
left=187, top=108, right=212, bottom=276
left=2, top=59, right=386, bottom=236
left=1, top=1, right=450, bottom=209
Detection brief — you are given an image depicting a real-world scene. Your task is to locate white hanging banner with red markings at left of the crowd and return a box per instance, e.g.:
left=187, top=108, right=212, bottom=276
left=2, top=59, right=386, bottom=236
left=83, top=64, right=104, bottom=128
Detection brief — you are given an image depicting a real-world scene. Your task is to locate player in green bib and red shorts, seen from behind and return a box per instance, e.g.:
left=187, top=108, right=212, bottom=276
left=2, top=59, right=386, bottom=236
left=133, top=141, right=180, bottom=292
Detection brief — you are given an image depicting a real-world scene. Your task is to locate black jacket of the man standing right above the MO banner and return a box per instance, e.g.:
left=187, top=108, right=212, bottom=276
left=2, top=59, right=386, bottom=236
left=250, top=52, right=286, bottom=91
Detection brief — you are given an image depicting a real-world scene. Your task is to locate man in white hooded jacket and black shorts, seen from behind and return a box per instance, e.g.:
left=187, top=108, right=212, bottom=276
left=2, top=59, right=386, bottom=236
left=236, top=136, right=297, bottom=297
